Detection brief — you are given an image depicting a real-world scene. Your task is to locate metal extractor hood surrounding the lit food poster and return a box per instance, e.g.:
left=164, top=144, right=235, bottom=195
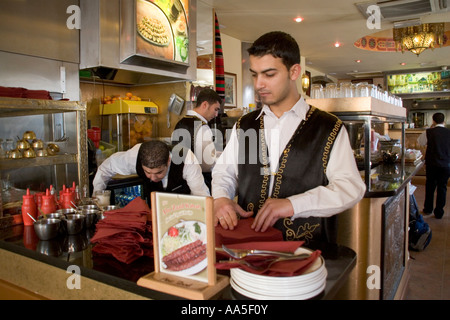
left=80, top=0, right=197, bottom=85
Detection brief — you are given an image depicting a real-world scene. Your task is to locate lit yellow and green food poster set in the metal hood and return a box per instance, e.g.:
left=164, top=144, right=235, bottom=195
left=136, top=0, right=189, bottom=63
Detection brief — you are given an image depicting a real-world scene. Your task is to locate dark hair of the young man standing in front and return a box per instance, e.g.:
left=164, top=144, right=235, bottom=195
left=247, top=31, right=300, bottom=70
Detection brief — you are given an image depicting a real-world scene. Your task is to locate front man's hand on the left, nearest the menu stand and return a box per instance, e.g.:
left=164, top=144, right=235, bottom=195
left=214, top=198, right=253, bottom=230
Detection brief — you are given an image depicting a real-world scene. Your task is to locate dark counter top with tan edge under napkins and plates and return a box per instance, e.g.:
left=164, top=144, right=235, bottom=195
left=0, top=225, right=356, bottom=300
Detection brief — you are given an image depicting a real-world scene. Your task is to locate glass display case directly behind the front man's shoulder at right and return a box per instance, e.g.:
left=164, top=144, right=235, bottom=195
left=307, top=97, right=406, bottom=197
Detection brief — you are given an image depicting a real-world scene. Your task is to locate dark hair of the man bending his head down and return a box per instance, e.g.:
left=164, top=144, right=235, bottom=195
left=138, top=140, right=170, bottom=169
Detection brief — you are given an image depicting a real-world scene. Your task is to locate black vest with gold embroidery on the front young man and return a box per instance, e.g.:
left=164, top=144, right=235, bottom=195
left=236, top=107, right=342, bottom=242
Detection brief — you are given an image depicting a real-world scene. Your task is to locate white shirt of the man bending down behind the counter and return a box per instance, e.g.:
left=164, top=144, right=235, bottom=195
left=93, top=143, right=210, bottom=196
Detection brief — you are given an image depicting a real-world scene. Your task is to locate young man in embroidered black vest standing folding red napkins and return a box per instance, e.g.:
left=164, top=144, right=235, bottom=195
left=212, top=32, right=365, bottom=241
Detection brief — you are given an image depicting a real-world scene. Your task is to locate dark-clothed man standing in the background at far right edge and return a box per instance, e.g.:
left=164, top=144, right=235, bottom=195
left=418, top=112, right=450, bottom=219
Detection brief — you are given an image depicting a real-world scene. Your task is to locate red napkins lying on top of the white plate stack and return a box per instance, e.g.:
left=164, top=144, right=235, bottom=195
left=215, top=241, right=322, bottom=277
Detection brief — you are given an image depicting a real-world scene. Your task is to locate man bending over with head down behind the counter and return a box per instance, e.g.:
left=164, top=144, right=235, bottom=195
left=93, top=140, right=210, bottom=206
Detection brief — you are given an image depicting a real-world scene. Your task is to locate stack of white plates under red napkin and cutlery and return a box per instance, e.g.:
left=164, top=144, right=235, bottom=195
left=230, top=249, right=327, bottom=300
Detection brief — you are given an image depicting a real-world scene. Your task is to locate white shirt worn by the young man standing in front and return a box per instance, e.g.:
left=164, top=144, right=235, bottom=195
left=212, top=97, right=366, bottom=219
